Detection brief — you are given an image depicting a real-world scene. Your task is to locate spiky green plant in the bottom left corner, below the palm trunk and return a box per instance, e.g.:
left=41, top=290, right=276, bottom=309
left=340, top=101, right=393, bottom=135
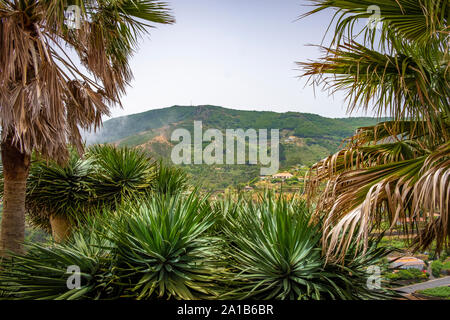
left=0, top=220, right=119, bottom=300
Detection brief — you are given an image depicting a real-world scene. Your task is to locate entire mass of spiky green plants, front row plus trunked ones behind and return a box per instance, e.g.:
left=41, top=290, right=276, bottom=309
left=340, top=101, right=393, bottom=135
left=0, top=145, right=400, bottom=300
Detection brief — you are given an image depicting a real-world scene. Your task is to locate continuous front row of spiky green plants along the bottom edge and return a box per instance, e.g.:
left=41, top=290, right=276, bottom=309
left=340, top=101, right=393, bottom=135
left=0, top=190, right=398, bottom=299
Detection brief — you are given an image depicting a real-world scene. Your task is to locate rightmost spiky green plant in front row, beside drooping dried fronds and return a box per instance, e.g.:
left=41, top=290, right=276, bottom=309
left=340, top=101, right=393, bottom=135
left=223, top=194, right=389, bottom=300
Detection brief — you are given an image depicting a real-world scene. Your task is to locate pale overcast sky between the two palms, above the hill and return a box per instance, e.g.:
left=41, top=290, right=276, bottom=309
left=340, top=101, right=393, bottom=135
left=113, top=0, right=370, bottom=117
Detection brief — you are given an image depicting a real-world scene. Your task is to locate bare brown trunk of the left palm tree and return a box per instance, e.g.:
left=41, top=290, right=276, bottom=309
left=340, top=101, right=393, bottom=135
left=0, top=137, right=30, bottom=256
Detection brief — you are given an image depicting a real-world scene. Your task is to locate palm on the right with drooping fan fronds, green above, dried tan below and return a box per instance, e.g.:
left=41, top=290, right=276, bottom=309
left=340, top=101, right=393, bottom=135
left=299, top=0, right=450, bottom=258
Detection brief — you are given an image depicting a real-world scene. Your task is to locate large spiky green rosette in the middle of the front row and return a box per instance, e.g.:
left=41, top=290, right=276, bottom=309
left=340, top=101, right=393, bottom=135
left=104, top=193, right=218, bottom=299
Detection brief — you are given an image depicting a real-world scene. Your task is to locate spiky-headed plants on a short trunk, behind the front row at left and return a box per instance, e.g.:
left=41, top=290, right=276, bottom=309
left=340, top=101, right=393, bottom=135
left=0, top=145, right=159, bottom=241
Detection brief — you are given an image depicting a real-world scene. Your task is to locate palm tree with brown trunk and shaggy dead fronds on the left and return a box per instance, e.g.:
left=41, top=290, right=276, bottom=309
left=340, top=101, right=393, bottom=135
left=0, top=0, right=174, bottom=254
